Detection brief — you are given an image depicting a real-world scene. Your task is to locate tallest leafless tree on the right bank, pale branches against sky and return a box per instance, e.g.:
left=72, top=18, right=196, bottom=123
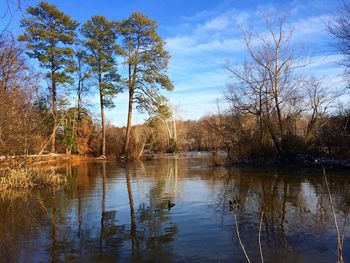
left=226, top=17, right=306, bottom=157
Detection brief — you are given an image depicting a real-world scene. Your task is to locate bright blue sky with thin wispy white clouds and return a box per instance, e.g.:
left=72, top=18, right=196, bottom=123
left=0, top=0, right=345, bottom=126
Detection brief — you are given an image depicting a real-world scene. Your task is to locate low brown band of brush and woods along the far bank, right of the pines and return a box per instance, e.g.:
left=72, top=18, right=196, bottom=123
left=102, top=108, right=350, bottom=163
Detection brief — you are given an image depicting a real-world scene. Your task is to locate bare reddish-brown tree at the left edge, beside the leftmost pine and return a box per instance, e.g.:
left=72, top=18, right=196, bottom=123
left=0, top=37, right=43, bottom=155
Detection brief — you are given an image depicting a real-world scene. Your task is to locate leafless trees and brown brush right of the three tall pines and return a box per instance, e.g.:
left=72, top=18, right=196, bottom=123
left=107, top=14, right=350, bottom=166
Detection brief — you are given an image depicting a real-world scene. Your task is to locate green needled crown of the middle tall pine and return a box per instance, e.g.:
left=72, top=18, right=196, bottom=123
left=80, top=16, right=121, bottom=107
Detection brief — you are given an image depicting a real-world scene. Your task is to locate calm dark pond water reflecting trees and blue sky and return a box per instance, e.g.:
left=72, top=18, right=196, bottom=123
left=0, top=158, right=350, bottom=263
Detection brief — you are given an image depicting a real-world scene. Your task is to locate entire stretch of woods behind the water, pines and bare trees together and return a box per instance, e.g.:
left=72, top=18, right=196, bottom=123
left=0, top=2, right=350, bottom=163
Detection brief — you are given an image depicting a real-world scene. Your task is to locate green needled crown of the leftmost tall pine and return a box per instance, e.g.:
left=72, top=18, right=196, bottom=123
left=18, top=2, right=79, bottom=84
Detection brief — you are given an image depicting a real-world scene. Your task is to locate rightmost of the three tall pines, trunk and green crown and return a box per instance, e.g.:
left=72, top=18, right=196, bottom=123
left=119, top=12, right=173, bottom=158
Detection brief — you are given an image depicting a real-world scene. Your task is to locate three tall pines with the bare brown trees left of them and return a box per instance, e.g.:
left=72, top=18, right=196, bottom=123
left=0, top=2, right=173, bottom=157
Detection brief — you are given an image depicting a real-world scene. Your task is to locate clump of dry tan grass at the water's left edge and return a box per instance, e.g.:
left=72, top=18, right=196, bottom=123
left=0, top=168, right=67, bottom=191
